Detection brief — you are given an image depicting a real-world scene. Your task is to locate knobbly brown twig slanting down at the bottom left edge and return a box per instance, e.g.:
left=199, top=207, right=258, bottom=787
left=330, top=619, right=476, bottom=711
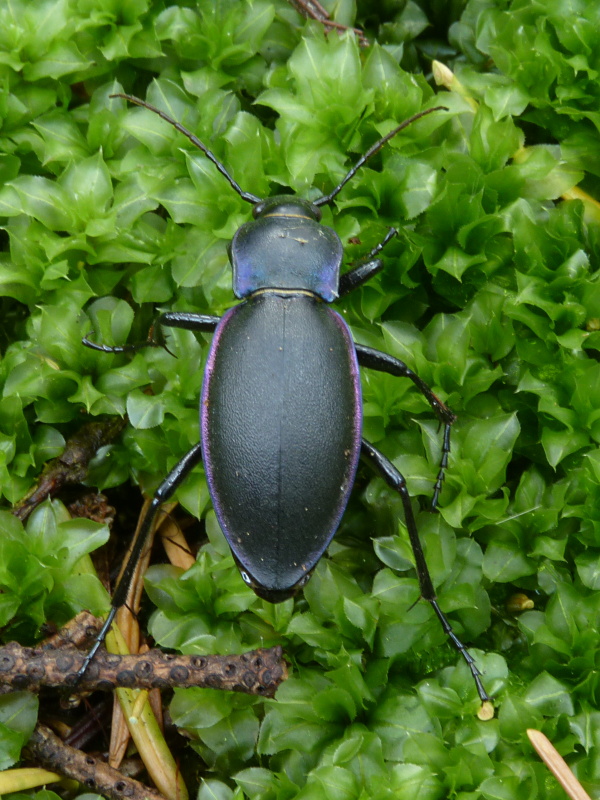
left=27, top=724, right=164, bottom=800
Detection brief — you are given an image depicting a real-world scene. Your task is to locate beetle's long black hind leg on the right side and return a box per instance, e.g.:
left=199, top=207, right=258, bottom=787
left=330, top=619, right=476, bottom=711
left=361, top=439, right=490, bottom=702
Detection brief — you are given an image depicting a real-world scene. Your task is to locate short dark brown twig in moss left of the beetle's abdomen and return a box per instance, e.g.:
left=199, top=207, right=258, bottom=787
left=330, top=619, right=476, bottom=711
left=13, top=417, right=126, bottom=521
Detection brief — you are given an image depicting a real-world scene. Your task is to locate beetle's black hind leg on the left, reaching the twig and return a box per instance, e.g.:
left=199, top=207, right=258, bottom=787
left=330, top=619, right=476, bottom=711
left=75, top=444, right=202, bottom=685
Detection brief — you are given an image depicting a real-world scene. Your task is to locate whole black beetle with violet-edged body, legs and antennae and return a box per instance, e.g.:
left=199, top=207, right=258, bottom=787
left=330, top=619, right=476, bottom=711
left=79, top=94, right=489, bottom=702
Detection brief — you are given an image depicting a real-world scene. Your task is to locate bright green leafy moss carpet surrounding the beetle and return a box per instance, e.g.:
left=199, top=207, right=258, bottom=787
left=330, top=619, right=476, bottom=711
left=0, top=0, right=600, bottom=800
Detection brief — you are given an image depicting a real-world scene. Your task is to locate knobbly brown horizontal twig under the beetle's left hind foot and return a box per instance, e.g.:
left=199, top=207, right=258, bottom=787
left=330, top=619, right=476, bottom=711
left=0, top=642, right=287, bottom=697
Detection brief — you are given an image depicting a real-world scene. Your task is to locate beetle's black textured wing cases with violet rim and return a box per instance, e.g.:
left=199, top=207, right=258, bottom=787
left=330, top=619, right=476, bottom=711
left=201, top=293, right=361, bottom=590
